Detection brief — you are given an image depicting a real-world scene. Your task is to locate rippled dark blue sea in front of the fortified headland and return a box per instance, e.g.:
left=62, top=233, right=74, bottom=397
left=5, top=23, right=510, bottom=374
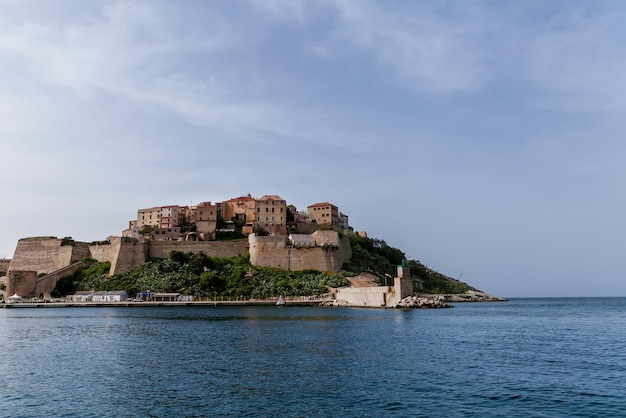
left=0, top=298, right=626, bottom=417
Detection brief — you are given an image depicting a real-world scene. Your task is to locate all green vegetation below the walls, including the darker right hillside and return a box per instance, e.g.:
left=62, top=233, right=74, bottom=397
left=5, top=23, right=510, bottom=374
left=53, top=234, right=471, bottom=299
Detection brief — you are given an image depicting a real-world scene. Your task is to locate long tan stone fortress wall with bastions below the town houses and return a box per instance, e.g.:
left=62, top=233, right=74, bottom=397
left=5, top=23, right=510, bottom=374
left=5, top=231, right=352, bottom=297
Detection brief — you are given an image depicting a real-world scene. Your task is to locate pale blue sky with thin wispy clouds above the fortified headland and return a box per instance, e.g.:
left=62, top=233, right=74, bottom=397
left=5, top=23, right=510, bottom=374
left=0, top=0, right=626, bottom=298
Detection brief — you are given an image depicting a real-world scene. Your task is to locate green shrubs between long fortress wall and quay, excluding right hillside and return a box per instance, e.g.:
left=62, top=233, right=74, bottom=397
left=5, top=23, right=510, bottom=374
left=59, top=251, right=348, bottom=299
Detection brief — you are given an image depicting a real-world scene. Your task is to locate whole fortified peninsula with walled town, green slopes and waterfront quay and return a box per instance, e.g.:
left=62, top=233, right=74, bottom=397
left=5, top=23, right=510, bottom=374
left=0, top=195, right=501, bottom=307
